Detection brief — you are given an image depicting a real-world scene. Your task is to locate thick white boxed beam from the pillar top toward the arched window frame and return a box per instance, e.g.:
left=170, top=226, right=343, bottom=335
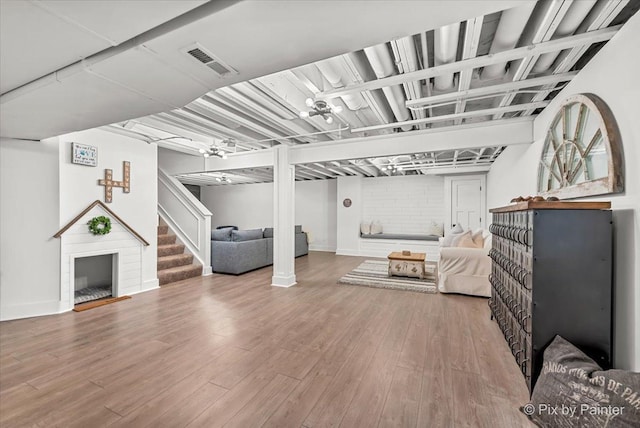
left=288, top=116, right=534, bottom=164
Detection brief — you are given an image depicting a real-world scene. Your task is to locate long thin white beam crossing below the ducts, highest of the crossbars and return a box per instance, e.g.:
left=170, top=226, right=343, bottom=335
left=317, top=25, right=621, bottom=100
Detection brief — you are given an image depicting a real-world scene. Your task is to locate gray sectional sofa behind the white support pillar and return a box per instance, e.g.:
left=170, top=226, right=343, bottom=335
left=211, top=226, right=309, bottom=275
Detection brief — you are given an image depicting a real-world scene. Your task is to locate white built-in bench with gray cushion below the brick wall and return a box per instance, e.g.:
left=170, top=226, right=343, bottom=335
left=359, top=233, right=440, bottom=262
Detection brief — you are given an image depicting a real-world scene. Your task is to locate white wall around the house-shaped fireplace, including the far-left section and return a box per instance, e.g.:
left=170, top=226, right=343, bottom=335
left=0, top=130, right=158, bottom=319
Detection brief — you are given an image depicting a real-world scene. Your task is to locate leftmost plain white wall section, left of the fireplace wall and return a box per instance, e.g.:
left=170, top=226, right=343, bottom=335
left=0, top=139, right=60, bottom=320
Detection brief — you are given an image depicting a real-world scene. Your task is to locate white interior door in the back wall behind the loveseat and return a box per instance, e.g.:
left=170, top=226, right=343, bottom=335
left=445, top=176, right=486, bottom=230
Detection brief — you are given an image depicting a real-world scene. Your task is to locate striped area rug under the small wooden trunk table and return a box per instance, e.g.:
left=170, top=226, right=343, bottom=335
left=338, top=260, right=437, bottom=293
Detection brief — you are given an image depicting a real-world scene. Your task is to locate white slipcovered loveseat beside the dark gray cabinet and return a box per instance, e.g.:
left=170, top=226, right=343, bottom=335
left=438, top=231, right=491, bottom=297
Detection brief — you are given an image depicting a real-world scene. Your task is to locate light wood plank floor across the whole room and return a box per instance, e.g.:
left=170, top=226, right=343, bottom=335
left=0, top=253, right=529, bottom=428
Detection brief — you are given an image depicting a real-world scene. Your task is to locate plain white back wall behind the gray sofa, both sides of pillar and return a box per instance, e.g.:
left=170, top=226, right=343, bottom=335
left=201, top=180, right=337, bottom=251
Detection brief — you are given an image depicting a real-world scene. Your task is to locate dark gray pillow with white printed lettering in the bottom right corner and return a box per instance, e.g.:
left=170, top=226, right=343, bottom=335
left=522, top=336, right=640, bottom=428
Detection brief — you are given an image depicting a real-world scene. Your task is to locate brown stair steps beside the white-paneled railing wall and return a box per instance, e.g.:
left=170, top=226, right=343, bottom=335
left=158, top=224, right=202, bottom=285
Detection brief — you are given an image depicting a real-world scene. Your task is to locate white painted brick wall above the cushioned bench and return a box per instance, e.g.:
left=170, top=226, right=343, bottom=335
left=361, top=176, right=445, bottom=233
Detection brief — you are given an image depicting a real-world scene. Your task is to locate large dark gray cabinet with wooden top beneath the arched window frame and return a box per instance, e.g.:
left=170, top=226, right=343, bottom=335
left=489, top=202, right=613, bottom=391
